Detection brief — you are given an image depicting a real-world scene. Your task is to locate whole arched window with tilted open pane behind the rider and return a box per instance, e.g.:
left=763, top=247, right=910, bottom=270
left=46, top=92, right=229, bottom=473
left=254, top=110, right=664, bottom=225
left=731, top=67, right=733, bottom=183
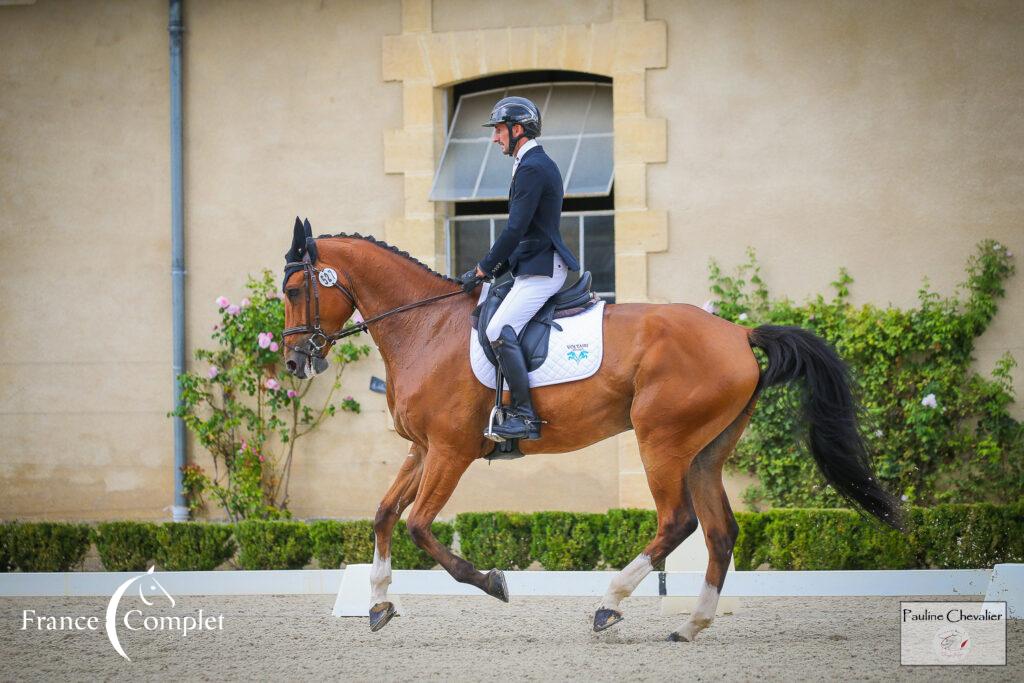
left=430, top=72, right=615, bottom=303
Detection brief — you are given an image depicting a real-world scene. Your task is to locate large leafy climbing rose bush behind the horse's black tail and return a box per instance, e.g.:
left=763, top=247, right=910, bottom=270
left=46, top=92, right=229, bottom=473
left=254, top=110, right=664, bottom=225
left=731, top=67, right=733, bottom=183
left=705, top=240, right=1024, bottom=508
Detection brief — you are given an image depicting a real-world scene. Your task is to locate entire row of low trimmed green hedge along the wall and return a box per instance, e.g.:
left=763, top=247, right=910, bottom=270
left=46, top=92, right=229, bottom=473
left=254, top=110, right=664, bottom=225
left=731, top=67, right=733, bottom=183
left=0, top=501, right=1024, bottom=571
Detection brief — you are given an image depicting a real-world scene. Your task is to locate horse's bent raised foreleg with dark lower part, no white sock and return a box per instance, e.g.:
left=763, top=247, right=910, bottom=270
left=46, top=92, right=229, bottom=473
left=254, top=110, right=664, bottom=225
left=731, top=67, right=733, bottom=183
left=409, top=447, right=508, bottom=602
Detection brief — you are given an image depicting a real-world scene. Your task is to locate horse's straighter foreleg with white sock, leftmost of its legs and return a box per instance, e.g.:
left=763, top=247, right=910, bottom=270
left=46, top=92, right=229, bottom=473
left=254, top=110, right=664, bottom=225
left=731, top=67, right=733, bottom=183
left=370, top=443, right=423, bottom=631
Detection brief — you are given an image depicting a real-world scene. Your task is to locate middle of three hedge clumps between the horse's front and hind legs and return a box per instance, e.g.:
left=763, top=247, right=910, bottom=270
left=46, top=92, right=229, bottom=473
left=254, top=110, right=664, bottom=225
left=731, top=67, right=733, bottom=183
left=529, top=512, right=607, bottom=570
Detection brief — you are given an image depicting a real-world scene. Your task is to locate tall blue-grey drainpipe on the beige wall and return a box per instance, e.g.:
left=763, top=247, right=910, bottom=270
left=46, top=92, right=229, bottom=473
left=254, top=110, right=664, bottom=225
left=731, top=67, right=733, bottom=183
left=167, top=0, right=188, bottom=522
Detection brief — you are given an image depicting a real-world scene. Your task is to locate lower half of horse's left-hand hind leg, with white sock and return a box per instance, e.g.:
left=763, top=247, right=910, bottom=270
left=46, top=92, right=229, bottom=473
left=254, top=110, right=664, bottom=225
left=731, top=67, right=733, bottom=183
left=594, top=461, right=697, bottom=631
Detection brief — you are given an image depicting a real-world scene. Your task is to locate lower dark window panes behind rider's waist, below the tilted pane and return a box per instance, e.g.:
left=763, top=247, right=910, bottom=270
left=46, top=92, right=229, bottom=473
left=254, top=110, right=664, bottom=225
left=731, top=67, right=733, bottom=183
left=444, top=211, right=615, bottom=303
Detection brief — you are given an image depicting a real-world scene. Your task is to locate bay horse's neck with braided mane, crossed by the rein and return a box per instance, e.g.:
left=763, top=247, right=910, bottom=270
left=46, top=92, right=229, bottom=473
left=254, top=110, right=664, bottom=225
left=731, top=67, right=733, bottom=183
left=327, top=243, right=473, bottom=373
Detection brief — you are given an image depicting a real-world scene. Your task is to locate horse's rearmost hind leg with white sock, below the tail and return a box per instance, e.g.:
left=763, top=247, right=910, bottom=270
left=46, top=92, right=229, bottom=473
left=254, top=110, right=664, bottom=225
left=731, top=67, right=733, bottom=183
left=669, top=409, right=754, bottom=641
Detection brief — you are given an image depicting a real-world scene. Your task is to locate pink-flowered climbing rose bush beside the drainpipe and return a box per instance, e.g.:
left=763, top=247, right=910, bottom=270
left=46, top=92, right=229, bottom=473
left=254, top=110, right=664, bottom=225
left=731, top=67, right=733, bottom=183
left=171, top=270, right=370, bottom=521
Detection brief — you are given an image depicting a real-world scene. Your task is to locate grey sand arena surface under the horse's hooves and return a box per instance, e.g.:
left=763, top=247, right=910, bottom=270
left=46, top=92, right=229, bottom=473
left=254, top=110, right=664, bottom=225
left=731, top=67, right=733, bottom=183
left=0, top=595, right=1024, bottom=681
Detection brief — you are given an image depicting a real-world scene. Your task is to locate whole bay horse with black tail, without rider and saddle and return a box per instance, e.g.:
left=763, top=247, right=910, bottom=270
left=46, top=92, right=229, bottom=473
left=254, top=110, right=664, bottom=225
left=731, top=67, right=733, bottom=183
left=283, top=219, right=901, bottom=641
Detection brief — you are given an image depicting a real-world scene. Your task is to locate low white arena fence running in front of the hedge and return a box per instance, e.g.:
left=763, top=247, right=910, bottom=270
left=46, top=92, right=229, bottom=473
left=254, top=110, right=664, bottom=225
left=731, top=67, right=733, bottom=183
left=0, top=564, right=1024, bottom=618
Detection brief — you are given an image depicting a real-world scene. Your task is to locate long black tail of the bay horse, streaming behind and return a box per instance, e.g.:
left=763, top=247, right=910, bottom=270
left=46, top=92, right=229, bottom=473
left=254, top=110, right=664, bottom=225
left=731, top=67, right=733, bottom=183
left=750, top=325, right=903, bottom=529
